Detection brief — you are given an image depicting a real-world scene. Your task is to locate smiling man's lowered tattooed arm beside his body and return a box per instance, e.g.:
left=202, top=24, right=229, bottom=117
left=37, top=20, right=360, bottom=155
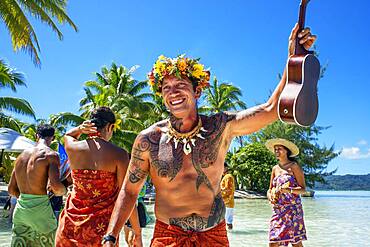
left=104, top=134, right=150, bottom=246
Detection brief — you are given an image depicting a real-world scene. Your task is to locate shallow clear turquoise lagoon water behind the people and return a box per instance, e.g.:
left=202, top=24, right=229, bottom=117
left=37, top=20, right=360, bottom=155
left=0, top=191, right=370, bottom=247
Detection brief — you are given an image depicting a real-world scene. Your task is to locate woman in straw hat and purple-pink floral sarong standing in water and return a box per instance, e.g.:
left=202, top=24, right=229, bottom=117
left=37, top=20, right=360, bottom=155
left=266, top=139, right=307, bottom=247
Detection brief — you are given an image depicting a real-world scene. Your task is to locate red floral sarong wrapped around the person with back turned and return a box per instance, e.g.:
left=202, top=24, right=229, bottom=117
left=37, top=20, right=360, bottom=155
left=55, top=169, right=119, bottom=247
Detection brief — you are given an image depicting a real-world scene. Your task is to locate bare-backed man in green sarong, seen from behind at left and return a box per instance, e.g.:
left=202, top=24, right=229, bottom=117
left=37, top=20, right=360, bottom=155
left=8, top=125, right=66, bottom=246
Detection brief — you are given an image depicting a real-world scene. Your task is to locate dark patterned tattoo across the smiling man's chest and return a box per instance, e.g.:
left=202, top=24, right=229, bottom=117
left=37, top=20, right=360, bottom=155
left=146, top=113, right=234, bottom=191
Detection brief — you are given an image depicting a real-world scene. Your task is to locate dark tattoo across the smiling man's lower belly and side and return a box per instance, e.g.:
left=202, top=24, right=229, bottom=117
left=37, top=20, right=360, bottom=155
left=169, top=193, right=226, bottom=231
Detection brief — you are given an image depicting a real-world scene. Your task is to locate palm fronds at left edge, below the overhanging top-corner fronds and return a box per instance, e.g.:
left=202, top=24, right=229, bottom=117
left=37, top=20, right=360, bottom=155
left=0, top=60, right=35, bottom=131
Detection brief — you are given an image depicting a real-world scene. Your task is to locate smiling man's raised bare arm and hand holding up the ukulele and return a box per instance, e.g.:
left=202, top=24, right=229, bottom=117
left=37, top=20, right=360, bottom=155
left=228, top=24, right=316, bottom=138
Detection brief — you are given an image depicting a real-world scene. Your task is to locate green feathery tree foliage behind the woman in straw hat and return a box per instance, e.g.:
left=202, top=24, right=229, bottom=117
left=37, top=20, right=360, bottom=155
left=249, top=121, right=340, bottom=187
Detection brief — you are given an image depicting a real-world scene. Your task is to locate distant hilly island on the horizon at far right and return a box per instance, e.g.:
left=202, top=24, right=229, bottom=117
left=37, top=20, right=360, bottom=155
left=314, top=173, right=370, bottom=190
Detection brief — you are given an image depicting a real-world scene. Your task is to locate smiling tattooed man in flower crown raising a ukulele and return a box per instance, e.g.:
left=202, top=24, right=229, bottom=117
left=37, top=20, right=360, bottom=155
left=103, top=25, right=316, bottom=247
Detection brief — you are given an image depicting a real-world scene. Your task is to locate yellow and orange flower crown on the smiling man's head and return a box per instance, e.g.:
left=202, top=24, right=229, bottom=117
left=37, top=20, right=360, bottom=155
left=148, top=55, right=210, bottom=96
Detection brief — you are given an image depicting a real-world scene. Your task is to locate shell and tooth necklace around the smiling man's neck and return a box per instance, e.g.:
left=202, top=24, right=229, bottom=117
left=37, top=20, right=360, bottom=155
left=165, top=117, right=207, bottom=155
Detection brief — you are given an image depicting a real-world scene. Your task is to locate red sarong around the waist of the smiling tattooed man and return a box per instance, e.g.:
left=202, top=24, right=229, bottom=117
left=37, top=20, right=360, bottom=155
left=150, top=220, right=229, bottom=247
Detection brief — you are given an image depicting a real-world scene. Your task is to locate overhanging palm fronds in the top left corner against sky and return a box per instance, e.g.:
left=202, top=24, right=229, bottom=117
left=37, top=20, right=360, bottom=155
left=0, top=0, right=77, bottom=65
